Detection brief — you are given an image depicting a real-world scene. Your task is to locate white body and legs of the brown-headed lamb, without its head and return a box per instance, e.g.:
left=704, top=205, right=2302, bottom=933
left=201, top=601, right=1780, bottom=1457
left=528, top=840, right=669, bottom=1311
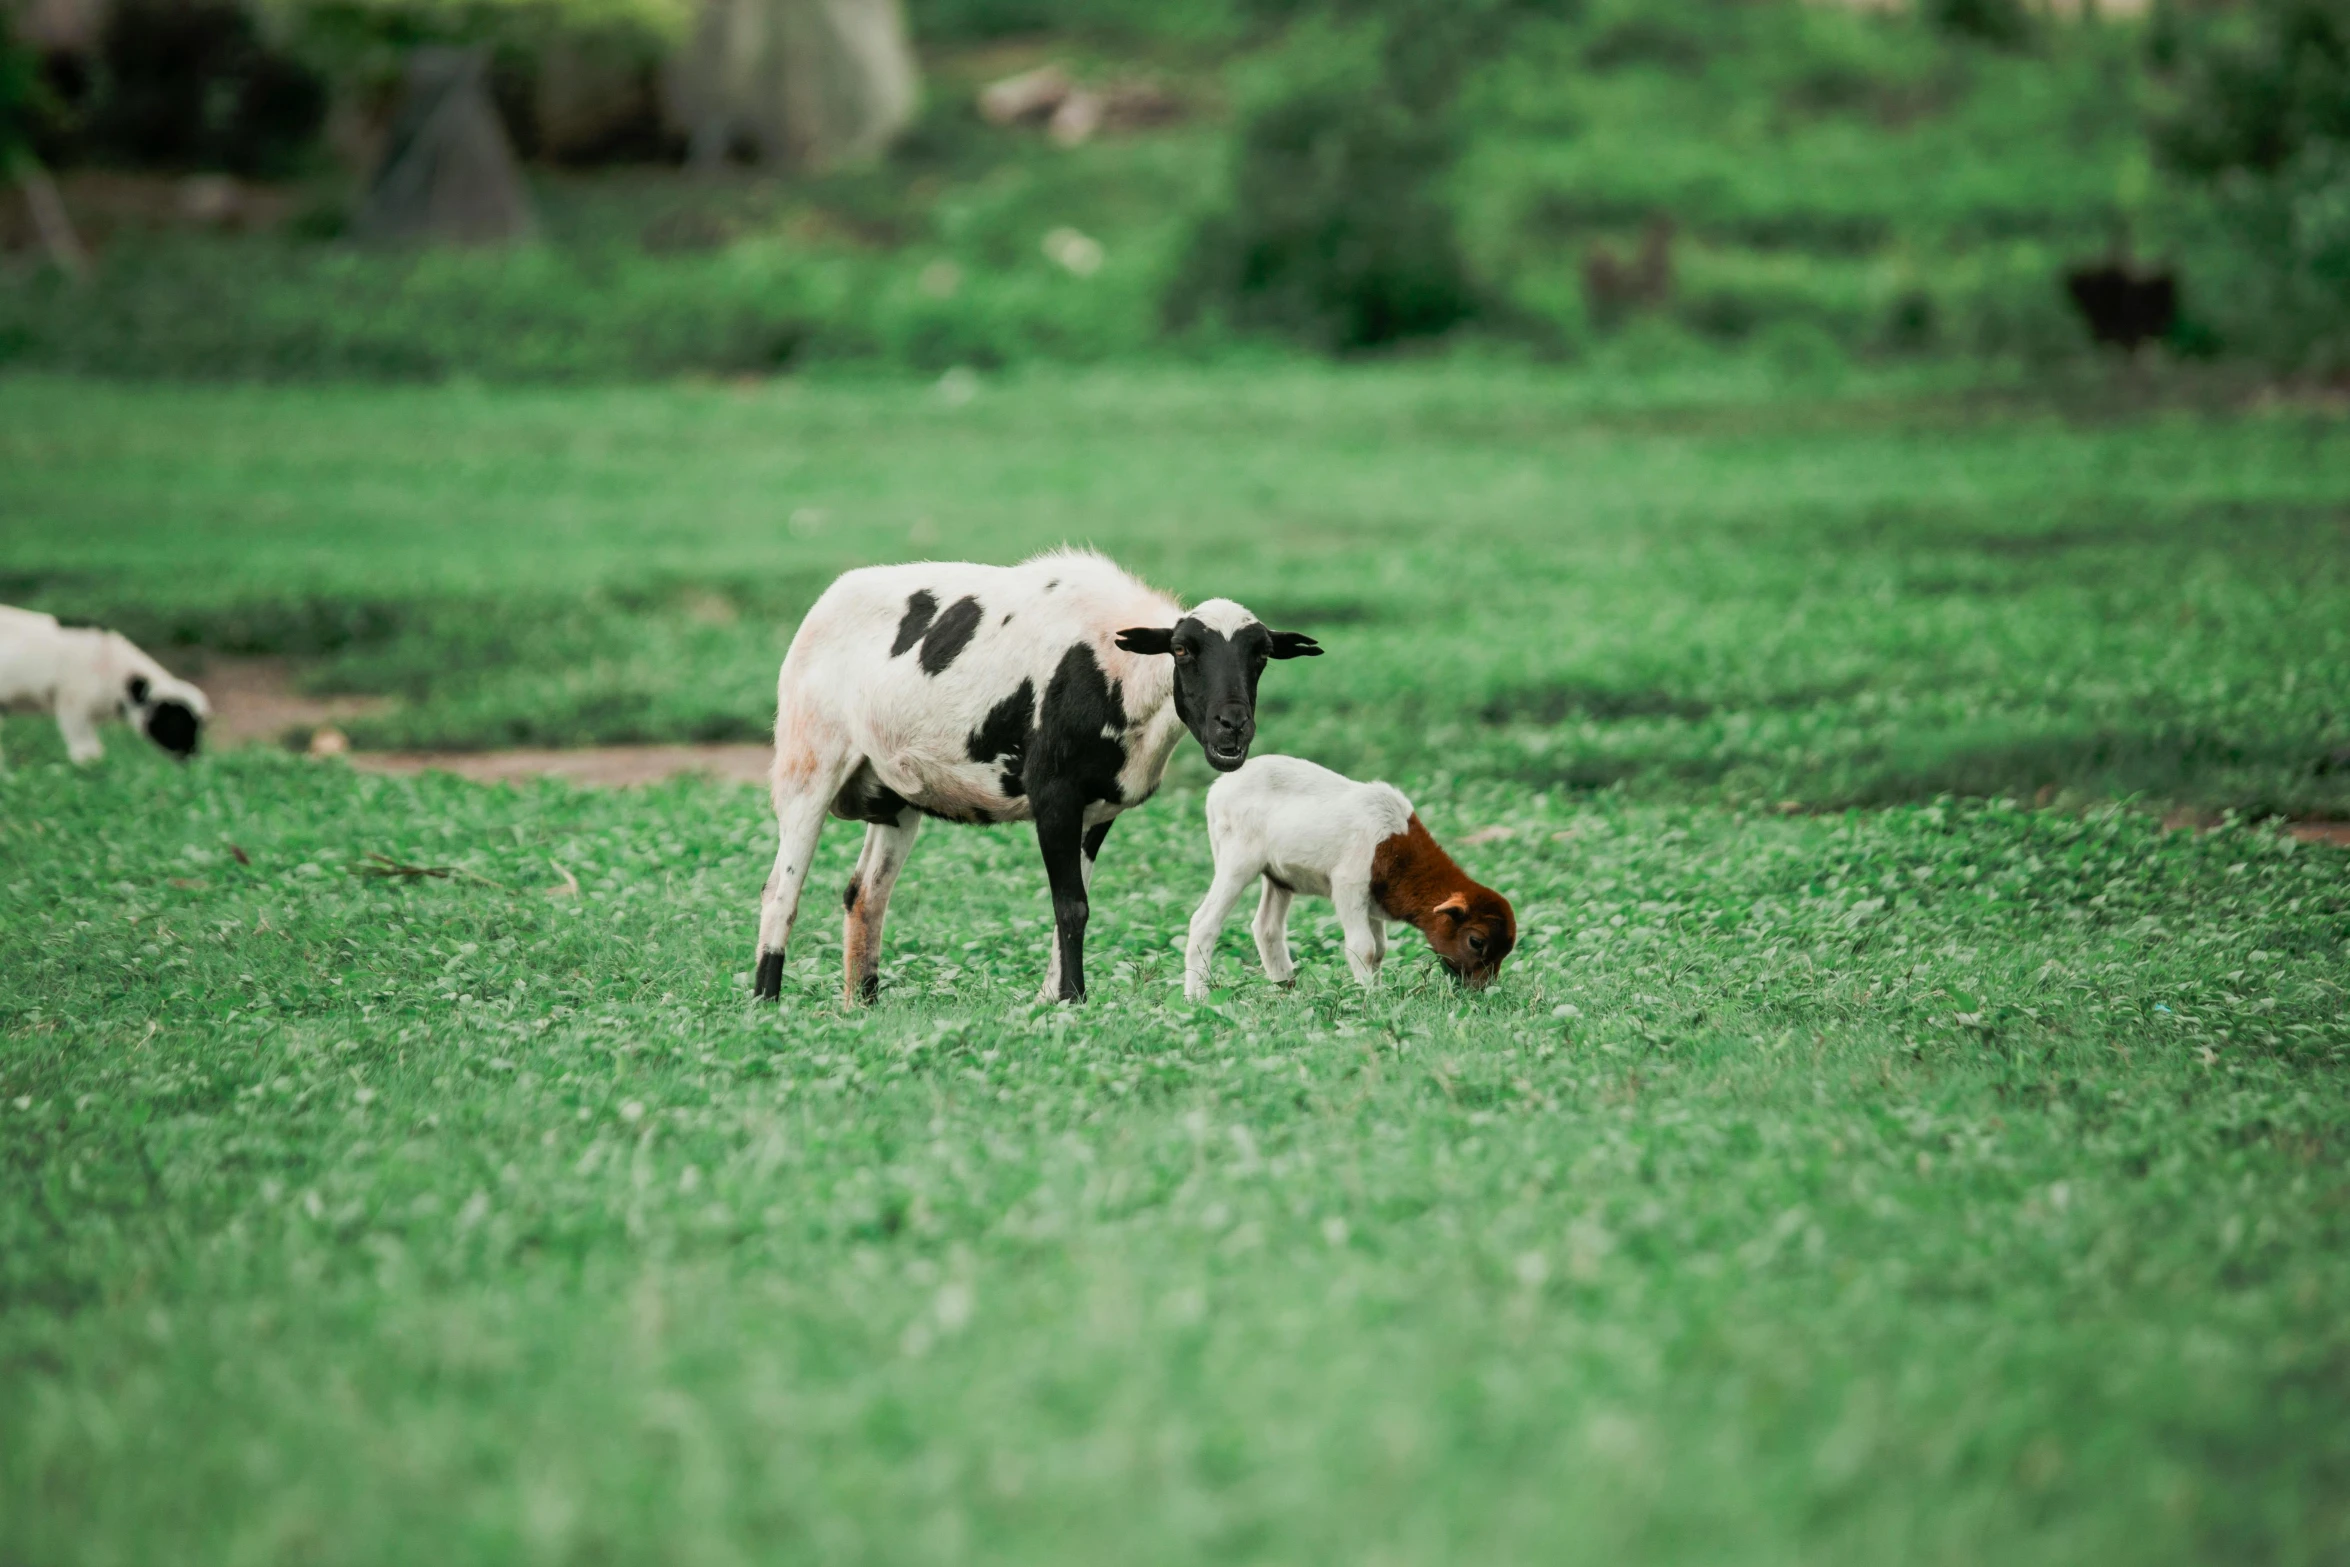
left=1182, top=756, right=1412, bottom=1001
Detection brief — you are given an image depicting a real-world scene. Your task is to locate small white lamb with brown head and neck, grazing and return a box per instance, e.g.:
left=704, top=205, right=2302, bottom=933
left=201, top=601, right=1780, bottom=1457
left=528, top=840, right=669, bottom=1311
left=1182, top=756, right=1518, bottom=1001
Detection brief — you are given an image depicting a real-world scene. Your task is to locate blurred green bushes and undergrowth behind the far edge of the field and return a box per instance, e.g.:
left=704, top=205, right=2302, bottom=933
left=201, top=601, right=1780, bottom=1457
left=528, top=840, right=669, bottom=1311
left=0, top=0, right=2350, bottom=378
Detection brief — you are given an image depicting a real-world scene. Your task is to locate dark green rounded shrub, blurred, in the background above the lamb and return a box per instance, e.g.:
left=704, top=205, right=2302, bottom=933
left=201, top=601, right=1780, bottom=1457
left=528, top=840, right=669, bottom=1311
left=1168, top=87, right=1476, bottom=352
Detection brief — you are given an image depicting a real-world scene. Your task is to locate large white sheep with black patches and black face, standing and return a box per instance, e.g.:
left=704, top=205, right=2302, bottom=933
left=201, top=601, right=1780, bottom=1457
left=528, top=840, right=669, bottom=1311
left=754, top=550, right=1321, bottom=1001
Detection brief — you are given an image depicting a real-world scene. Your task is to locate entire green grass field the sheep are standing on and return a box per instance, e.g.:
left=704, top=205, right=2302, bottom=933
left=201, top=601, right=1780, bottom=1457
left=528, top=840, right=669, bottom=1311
left=0, top=355, right=2350, bottom=1565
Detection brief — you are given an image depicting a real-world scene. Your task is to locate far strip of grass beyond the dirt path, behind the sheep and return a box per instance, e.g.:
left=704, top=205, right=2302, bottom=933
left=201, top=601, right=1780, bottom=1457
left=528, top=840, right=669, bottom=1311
left=0, top=359, right=2350, bottom=815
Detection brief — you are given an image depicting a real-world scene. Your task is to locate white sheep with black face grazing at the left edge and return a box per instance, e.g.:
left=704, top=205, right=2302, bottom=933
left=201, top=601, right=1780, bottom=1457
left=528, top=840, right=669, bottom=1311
left=0, top=606, right=212, bottom=761
